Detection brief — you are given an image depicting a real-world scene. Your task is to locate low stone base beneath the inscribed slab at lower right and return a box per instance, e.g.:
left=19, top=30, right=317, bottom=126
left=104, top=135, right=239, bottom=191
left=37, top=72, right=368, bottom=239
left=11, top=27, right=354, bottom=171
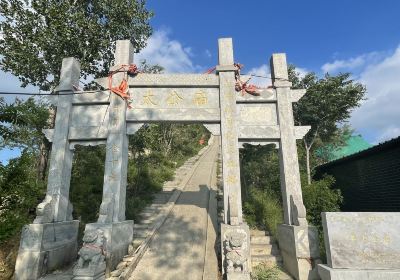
left=318, top=264, right=400, bottom=280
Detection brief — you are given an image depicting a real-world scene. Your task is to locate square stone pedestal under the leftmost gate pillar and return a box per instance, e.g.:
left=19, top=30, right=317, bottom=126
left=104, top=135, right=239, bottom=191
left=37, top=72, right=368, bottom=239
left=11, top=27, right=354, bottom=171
left=15, top=221, right=79, bottom=280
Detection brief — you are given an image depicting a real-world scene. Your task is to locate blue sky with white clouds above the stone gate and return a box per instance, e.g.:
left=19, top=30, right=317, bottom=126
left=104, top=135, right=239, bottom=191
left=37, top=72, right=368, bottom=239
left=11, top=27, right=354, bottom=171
left=0, top=0, right=400, bottom=164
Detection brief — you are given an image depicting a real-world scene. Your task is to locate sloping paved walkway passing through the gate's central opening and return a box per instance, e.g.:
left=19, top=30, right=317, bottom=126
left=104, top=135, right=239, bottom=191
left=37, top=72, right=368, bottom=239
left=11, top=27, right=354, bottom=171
left=130, top=141, right=219, bottom=280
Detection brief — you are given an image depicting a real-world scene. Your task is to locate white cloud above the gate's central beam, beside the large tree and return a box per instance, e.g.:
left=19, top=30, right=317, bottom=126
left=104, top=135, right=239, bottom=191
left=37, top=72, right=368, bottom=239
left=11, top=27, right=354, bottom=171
left=135, top=29, right=200, bottom=73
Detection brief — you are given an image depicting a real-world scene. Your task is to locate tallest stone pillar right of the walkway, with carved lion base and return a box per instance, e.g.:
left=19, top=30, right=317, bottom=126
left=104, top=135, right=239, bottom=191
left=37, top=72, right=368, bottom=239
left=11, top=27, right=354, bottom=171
left=217, top=38, right=251, bottom=280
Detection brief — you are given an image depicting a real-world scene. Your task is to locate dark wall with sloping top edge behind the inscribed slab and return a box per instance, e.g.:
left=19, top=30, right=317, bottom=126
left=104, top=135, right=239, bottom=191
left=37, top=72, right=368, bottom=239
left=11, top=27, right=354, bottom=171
left=317, top=137, right=400, bottom=212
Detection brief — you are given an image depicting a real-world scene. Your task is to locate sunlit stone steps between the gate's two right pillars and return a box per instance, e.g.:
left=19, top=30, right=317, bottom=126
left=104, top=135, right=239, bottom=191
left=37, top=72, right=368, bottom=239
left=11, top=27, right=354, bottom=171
left=250, top=229, right=293, bottom=280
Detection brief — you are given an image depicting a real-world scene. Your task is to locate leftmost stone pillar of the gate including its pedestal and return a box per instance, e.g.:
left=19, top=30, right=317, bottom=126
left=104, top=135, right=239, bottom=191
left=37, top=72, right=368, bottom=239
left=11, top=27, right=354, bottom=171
left=15, top=57, right=80, bottom=279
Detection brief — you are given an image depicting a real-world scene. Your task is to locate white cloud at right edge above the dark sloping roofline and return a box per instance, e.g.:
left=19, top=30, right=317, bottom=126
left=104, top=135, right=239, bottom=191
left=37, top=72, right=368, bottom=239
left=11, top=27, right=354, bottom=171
left=350, top=46, right=400, bottom=143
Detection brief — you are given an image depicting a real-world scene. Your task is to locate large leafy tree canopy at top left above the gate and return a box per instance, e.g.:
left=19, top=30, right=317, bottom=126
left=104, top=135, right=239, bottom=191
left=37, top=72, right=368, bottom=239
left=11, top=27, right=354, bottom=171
left=0, top=0, right=153, bottom=90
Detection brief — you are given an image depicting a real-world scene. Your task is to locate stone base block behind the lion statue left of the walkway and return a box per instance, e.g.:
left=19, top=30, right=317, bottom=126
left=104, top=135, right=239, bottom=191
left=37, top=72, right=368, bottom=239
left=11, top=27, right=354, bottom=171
left=85, top=221, right=133, bottom=279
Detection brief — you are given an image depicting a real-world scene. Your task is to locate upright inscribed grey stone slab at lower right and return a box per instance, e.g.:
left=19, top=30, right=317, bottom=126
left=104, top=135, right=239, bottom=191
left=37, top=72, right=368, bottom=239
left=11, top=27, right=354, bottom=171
left=322, top=212, right=400, bottom=269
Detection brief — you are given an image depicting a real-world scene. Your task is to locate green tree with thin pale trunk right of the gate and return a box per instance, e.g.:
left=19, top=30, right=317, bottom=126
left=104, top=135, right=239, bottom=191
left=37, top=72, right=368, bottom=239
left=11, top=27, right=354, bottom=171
left=289, top=66, right=366, bottom=184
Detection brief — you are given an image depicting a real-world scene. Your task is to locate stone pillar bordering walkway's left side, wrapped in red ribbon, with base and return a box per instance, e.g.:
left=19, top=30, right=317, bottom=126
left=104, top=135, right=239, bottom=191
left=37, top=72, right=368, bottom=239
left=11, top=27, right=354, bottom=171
left=74, top=40, right=134, bottom=279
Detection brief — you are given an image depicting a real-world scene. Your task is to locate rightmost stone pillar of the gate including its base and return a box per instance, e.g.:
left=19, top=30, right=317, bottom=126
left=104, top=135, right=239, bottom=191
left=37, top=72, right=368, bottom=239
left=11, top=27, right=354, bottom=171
left=270, top=54, right=320, bottom=280
